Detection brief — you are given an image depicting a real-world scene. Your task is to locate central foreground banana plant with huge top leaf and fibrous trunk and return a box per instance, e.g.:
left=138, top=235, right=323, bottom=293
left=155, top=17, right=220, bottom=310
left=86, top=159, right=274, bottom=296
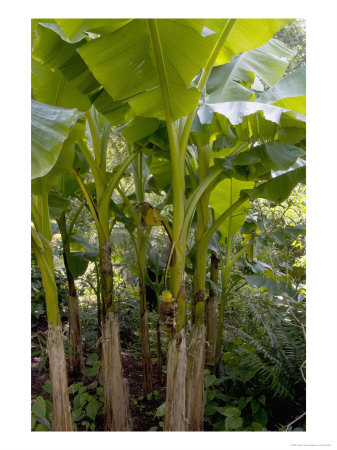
left=65, top=19, right=285, bottom=431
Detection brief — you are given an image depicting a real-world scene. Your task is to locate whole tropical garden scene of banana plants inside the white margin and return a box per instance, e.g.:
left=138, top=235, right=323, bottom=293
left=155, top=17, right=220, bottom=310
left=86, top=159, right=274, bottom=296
left=31, top=19, right=306, bottom=431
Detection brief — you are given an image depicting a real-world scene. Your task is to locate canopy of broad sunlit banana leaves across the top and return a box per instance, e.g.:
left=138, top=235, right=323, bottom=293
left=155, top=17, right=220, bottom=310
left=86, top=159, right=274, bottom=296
left=32, top=19, right=305, bottom=241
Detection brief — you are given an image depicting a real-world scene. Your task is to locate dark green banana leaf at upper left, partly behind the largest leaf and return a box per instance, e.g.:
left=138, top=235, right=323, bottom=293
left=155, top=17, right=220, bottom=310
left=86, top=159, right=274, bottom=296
left=32, top=20, right=133, bottom=125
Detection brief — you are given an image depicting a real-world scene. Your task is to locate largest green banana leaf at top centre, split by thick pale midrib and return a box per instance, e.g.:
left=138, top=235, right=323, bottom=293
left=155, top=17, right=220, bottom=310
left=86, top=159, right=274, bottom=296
left=79, top=19, right=216, bottom=119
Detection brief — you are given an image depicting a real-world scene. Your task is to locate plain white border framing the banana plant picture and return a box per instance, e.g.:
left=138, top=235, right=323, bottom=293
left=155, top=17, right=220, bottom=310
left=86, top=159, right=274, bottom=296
left=0, top=0, right=337, bottom=450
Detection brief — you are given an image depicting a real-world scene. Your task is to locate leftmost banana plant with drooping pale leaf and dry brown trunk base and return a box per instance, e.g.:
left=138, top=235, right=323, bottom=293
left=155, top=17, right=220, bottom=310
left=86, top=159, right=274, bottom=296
left=31, top=100, right=80, bottom=431
